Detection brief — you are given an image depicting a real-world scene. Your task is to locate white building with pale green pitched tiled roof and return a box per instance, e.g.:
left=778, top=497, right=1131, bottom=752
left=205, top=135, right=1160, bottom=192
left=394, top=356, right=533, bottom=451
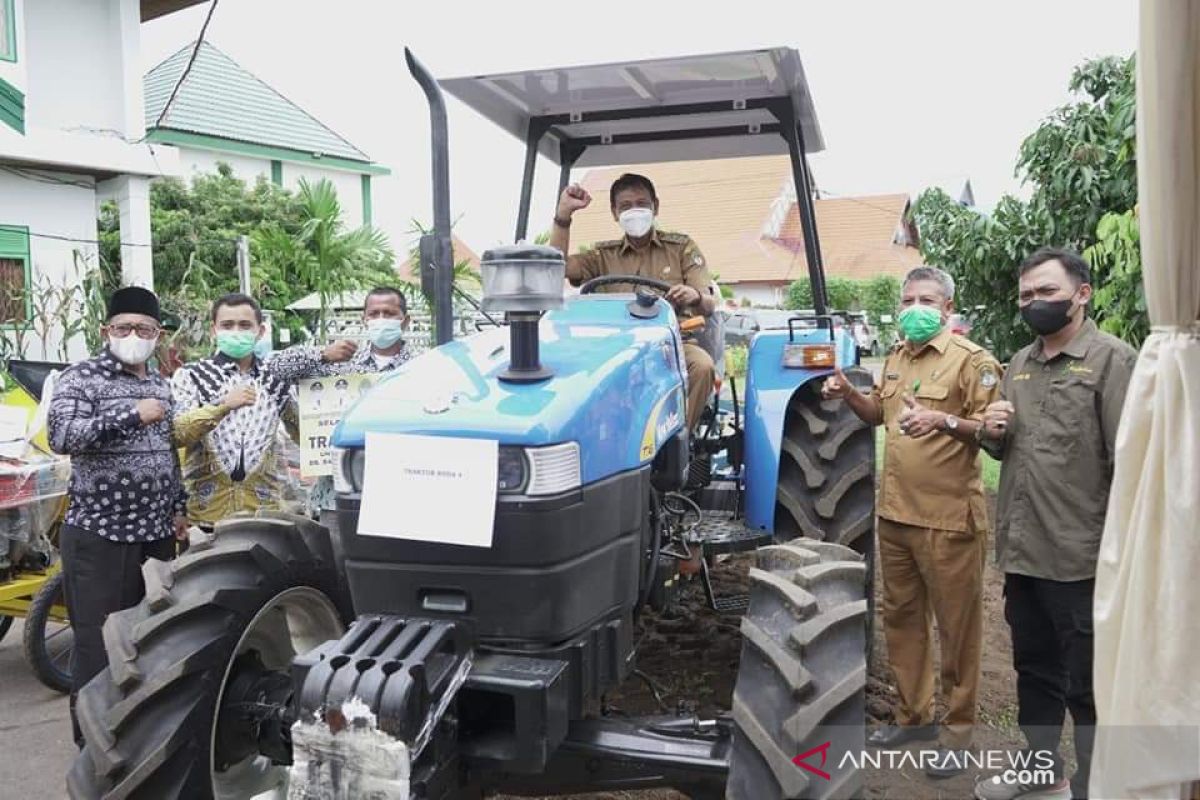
left=143, top=42, right=389, bottom=227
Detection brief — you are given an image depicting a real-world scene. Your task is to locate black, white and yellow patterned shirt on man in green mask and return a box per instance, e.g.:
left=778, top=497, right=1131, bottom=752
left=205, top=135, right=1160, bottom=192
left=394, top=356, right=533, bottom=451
left=172, top=348, right=322, bottom=525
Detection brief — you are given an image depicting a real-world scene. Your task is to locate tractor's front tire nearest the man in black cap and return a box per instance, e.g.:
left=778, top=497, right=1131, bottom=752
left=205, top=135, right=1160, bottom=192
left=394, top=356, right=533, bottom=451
left=67, top=516, right=349, bottom=800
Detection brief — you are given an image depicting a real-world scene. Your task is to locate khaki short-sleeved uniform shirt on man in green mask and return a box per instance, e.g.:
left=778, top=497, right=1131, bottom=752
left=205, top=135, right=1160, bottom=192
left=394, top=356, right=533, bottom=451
left=872, top=327, right=1001, bottom=533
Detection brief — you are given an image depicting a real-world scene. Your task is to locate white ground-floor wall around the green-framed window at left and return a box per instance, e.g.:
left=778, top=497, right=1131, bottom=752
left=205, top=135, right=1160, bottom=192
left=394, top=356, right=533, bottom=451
left=0, top=172, right=98, bottom=361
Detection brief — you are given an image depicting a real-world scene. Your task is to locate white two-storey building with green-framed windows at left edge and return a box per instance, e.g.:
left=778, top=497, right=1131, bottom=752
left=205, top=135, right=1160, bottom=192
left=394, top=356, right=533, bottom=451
left=0, top=0, right=202, bottom=357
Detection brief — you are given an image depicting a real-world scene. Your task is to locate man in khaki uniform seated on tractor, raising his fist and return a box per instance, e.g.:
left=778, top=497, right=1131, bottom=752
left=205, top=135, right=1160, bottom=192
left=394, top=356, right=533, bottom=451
left=550, top=173, right=716, bottom=431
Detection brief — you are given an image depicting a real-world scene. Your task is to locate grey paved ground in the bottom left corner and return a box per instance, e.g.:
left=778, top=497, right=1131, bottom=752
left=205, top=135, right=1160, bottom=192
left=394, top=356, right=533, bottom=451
left=0, top=620, right=76, bottom=800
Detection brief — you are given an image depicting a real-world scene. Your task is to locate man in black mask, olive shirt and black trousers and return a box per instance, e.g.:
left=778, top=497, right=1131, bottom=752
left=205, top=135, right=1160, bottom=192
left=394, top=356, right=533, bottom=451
left=976, top=247, right=1138, bottom=800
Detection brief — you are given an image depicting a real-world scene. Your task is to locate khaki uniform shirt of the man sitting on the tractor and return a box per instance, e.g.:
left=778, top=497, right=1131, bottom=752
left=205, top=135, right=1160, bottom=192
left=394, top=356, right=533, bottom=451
left=569, top=229, right=712, bottom=317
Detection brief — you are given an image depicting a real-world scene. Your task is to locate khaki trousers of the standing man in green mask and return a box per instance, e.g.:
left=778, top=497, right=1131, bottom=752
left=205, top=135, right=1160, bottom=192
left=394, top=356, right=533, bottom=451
left=878, top=518, right=988, bottom=748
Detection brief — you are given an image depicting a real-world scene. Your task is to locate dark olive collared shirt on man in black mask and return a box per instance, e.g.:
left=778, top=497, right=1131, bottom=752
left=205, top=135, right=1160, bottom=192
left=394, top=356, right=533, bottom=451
left=985, top=319, right=1138, bottom=581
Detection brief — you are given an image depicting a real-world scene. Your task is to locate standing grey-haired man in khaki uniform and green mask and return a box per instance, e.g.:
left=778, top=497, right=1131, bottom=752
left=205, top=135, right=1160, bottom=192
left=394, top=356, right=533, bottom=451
left=822, top=266, right=1001, bottom=777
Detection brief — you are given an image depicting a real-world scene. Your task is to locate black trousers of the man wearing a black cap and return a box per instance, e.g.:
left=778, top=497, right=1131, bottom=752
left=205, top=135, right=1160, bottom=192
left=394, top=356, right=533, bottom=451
left=59, top=525, right=175, bottom=747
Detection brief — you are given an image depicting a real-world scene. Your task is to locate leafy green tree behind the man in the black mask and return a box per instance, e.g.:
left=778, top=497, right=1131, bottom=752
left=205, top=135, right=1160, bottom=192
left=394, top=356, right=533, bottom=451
left=913, top=56, right=1145, bottom=359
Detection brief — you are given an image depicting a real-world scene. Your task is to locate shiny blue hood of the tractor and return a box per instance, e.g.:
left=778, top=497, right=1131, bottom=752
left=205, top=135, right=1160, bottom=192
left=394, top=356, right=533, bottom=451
left=334, top=295, right=684, bottom=482
